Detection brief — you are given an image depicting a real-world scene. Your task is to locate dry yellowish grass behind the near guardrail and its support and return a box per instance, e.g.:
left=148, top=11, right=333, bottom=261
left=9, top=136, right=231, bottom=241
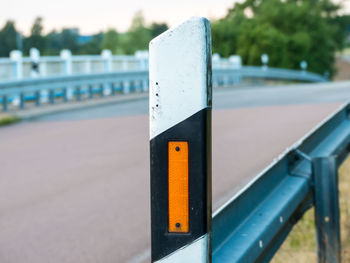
left=271, top=157, right=350, bottom=263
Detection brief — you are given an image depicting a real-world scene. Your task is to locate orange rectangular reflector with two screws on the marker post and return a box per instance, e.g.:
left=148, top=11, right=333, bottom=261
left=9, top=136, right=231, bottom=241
left=168, top=141, right=189, bottom=233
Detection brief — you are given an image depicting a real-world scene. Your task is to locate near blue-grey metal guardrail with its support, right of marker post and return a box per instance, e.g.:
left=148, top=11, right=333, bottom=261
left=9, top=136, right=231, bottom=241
left=213, top=104, right=350, bottom=262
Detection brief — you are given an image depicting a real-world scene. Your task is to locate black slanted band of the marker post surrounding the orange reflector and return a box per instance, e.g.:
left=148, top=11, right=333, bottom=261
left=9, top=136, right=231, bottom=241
left=150, top=108, right=212, bottom=262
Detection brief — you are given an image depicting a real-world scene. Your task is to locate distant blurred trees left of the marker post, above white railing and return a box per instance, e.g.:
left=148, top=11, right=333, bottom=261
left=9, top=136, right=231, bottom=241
left=0, top=11, right=168, bottom=57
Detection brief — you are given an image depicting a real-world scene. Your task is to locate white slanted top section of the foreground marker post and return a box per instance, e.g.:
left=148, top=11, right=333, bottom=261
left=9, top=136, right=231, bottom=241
left=149, top=17, right=211, bottom=139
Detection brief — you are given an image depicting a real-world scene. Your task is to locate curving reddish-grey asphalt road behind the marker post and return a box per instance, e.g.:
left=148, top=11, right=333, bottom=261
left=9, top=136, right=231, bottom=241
left=0, top=81, right=350, bottom=263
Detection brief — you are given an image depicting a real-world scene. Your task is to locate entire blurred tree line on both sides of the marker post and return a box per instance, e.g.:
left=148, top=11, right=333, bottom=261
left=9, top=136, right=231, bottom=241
left=0, top=0, right=350, bottom=76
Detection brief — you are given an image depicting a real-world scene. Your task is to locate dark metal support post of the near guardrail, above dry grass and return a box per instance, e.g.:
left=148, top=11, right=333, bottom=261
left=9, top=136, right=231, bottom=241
left=312, top=156, right=341, bottom=263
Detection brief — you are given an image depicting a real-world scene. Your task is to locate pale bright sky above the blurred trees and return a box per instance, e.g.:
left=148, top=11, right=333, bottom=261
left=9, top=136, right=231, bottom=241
left=0, top=0, right=350, bottom=35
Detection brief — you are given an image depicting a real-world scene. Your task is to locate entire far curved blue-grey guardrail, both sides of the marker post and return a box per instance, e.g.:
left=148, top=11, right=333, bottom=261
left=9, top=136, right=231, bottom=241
left=0, top=66, right=327, bottom=111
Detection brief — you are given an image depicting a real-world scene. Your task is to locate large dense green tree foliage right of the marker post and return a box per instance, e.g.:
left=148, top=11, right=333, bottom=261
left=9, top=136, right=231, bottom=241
left=212, top=0, right=349, bottom=78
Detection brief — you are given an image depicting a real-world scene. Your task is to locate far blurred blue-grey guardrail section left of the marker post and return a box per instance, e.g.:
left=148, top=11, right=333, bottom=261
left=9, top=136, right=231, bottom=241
left=0, top=70, right=148, bottom=111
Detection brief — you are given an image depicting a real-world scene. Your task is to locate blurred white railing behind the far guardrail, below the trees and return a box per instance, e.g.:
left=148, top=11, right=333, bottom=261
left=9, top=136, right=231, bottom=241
left=0, top=48, right=242, bottom=81
